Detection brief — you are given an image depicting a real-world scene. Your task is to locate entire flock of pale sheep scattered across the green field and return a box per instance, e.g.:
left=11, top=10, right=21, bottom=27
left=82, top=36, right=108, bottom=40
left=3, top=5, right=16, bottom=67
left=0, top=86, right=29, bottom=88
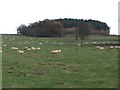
left=0, top=37, right=120, bottom=54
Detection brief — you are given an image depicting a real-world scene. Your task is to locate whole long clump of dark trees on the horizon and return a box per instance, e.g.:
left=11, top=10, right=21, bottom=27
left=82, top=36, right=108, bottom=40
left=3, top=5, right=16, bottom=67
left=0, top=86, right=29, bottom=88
left=17, top=18, right=110, bottom=38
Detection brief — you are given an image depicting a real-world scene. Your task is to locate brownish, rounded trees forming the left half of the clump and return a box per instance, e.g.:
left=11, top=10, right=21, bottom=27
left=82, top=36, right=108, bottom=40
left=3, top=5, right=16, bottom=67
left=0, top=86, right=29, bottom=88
left=17, top=20, right=63, bottom=37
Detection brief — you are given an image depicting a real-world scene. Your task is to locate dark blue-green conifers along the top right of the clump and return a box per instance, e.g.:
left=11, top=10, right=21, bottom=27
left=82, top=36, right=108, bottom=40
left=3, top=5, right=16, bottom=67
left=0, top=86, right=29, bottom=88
left=55, top=18, right=110, bottom=30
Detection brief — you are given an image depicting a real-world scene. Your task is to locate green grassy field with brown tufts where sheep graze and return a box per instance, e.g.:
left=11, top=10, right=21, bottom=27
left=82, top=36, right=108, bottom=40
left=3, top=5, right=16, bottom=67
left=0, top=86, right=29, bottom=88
left=2, top=35, right=118, bottom=88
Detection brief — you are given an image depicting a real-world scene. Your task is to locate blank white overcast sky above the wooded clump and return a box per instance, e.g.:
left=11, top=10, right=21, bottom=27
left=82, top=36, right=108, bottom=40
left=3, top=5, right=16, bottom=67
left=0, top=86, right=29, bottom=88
left=0, top=0, right=120, bottom=34
